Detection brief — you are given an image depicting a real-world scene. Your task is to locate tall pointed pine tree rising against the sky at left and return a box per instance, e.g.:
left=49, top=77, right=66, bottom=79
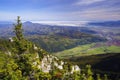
left=14, top=16, right=33, bottom=54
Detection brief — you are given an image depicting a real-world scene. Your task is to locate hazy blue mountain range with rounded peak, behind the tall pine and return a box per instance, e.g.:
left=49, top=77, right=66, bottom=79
left=0, top=21, right=96, bottom=36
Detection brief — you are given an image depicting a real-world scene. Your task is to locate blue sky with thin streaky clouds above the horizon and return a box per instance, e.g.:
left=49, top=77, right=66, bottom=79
left=0, top=0, right=120, bottom=21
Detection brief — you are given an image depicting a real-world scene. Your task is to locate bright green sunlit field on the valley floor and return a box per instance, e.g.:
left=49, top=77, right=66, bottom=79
left=54, top=43, right=120, bottom=59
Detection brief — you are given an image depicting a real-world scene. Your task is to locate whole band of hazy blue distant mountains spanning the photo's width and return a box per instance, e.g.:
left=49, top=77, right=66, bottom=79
left=0, top=21, right=120, bottom=39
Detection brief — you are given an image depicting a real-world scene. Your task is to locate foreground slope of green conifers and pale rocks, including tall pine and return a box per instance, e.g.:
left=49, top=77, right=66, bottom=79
left=0, top=17, right=107, bottom=80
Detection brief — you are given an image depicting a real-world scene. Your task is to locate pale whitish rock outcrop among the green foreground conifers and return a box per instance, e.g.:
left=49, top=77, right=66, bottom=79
left=33, top=54, right=80, bottom=74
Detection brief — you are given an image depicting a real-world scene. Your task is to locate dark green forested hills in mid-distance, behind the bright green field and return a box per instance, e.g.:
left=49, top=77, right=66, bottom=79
left=28, top=31, right=106, bottom=52
